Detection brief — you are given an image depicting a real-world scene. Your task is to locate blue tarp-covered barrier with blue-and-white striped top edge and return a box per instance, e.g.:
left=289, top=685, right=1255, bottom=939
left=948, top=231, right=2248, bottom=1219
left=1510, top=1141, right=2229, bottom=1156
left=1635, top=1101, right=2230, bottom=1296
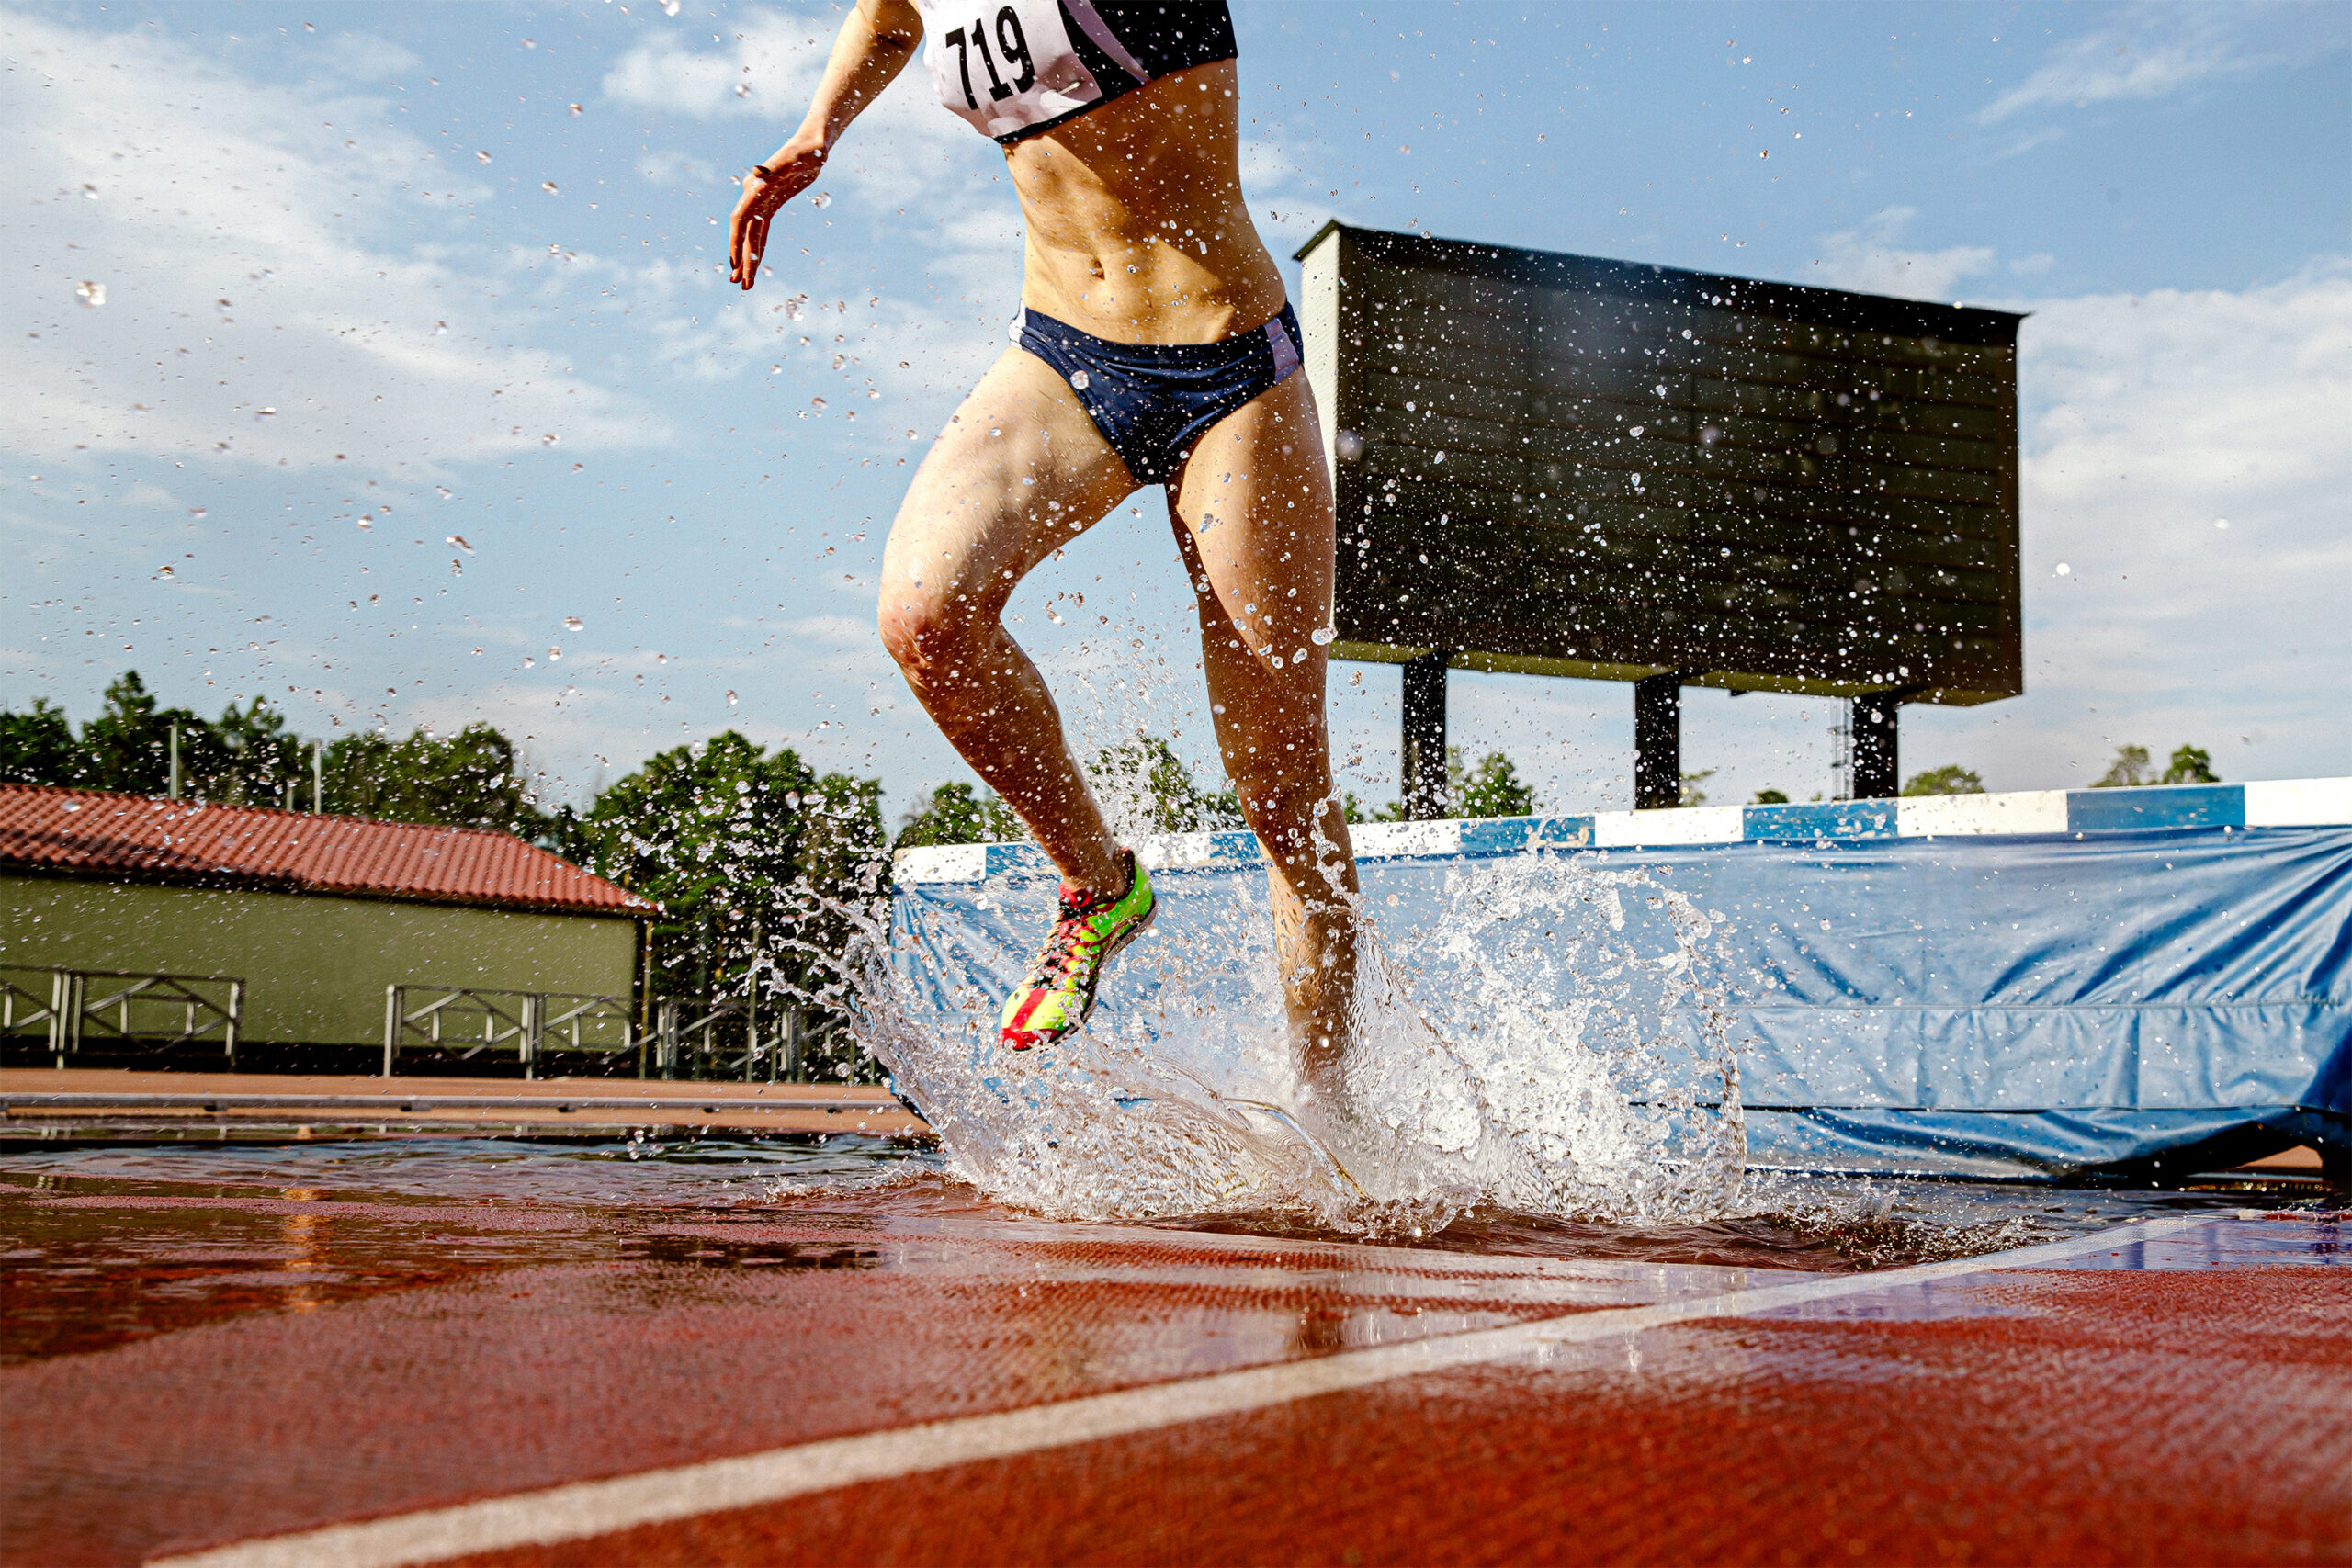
left=894, top=778, right=2352, bottom=1178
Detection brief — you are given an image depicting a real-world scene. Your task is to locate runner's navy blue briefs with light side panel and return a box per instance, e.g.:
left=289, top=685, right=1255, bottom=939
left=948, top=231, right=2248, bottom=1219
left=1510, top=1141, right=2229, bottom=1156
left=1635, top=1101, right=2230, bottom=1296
left=1021, top=306, right=1303, bottom=484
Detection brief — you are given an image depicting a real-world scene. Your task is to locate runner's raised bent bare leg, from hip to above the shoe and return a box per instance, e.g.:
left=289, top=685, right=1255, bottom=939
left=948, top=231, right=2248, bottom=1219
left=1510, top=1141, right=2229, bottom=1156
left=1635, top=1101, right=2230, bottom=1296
left=882, top=348, right=1136, bottom=891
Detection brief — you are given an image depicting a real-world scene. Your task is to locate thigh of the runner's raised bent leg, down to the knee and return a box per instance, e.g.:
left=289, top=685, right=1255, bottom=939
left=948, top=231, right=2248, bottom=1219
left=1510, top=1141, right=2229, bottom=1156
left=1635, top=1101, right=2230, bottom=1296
left=882, top=348, right=1136, bottom=626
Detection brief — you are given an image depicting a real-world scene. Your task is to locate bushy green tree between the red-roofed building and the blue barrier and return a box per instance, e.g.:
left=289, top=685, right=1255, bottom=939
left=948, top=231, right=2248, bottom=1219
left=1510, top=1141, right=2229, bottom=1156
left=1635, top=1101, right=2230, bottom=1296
left=555, top=731, right=887, bottom=1077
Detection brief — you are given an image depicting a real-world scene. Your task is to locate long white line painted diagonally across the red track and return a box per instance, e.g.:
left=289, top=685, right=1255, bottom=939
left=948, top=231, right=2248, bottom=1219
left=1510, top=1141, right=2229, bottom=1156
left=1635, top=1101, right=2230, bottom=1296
left=155, top=1211, right=2234, bottom=1568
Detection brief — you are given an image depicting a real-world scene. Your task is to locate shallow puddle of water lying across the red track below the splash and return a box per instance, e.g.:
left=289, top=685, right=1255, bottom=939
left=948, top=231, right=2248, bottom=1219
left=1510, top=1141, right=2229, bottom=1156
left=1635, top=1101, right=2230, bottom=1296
left=0, top=1138, right=2314, bottom=1363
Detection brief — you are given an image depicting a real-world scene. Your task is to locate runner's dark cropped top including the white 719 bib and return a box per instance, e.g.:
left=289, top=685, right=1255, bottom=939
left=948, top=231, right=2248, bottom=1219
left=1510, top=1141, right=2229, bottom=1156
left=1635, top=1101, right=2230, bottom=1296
left=915, top=0, right=1239, bottom=143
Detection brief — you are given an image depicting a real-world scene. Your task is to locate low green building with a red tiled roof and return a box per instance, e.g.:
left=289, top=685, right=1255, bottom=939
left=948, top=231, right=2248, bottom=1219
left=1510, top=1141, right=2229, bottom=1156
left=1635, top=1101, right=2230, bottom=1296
left=0, top=785, right=661, bottom=1069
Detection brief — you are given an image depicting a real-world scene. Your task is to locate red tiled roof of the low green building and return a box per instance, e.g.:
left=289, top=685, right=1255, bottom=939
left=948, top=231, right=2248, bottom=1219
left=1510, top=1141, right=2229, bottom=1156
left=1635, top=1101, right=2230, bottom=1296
left=0, top=785, right=654, bottom=915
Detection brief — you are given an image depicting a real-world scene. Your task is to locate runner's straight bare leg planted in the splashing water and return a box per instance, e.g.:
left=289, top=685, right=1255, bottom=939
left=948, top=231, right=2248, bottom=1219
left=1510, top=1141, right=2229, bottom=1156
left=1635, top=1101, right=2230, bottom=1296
left=1169, top=374, right=1357, bottom=1086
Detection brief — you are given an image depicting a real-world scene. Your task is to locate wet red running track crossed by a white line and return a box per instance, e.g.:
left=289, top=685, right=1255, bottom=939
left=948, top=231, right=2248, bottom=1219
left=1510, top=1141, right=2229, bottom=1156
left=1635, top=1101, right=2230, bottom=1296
left=0, top=1187, right=2352, bottom=1565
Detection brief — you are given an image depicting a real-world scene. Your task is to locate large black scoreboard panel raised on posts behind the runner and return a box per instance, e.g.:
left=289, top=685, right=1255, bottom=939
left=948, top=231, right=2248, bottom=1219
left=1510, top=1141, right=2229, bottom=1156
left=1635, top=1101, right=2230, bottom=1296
left=1298, top=223, right=2025, bottom=709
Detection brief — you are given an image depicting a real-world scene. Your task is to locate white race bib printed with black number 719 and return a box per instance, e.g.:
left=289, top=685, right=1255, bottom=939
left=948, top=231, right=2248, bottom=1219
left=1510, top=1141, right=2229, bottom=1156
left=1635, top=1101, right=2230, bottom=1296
left=917, top=0, right=1103, bottom=136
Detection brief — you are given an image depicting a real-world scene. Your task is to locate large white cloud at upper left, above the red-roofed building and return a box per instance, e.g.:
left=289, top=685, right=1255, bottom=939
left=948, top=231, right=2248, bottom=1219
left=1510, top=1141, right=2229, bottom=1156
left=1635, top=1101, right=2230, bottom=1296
left=0, top=12, right=665, bottom=468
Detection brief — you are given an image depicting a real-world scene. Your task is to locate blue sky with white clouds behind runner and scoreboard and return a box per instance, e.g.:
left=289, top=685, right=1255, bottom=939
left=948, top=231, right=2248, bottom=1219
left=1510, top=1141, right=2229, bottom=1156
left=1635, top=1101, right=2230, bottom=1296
left=0, top=0, right=2352, bottom=808
